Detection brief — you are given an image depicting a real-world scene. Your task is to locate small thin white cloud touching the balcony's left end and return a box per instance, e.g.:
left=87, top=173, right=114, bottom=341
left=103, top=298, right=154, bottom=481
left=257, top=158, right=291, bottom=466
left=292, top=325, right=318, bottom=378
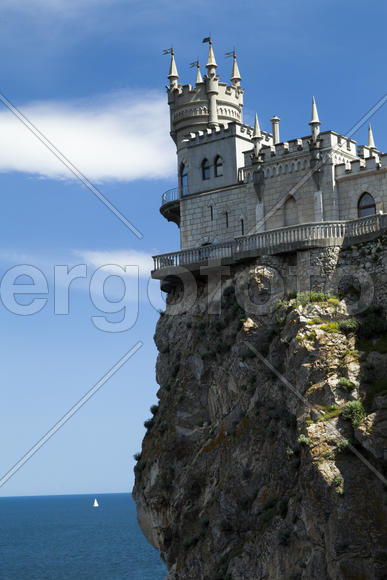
left=75, top=250, right=153, bottom=278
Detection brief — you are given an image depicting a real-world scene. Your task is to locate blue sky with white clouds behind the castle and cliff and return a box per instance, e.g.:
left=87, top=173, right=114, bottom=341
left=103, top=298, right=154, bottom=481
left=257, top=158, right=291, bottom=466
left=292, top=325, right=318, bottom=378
left=0, top=0, right=387, bottom=495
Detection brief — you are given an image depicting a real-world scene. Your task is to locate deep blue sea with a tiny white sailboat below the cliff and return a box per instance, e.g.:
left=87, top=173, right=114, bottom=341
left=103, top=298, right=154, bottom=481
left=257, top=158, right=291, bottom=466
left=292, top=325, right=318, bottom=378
left=0, top=493, right=167, bottom=580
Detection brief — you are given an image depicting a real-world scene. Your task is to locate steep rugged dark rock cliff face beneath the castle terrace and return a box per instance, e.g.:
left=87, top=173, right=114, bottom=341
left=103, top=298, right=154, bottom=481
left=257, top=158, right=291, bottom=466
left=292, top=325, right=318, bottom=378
left=133, top=238, right=387, bottom=580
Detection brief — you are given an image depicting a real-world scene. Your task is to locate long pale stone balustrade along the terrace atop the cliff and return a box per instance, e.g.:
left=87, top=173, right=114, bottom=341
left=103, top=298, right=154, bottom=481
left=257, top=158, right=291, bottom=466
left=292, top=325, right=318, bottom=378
left=153, top=214, right=387, bottom=270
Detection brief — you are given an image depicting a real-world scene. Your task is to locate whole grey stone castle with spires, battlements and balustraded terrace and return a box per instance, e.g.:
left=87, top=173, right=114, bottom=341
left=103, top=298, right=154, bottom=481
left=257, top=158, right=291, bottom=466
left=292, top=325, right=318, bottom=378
left=153, top=40, right=387, bottom=279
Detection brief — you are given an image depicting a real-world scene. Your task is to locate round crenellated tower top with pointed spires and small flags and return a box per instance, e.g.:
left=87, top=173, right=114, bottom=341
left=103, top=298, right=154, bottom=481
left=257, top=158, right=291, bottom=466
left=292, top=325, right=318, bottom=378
left=167, top=41, right=244, bottom=150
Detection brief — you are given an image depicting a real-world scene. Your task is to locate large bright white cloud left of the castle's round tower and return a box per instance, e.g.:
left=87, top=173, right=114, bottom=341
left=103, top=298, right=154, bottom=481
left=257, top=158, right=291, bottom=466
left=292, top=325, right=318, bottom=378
left=0, top=91, right=175, bottom=181
